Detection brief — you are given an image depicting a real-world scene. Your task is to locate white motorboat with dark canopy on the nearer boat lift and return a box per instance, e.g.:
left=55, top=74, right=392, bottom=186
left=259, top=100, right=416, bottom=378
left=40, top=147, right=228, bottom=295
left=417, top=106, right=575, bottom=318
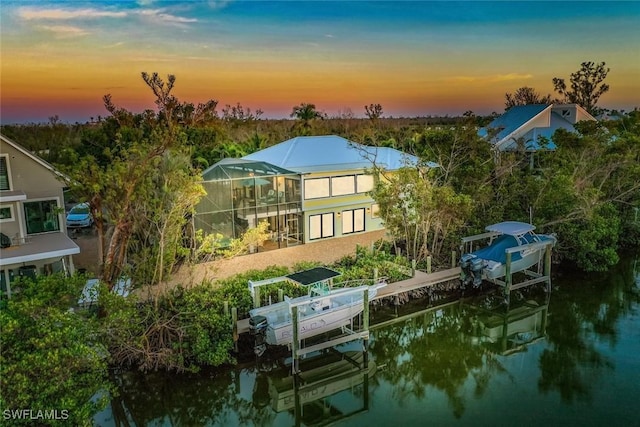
left=249, top=267, right=386, bottom=355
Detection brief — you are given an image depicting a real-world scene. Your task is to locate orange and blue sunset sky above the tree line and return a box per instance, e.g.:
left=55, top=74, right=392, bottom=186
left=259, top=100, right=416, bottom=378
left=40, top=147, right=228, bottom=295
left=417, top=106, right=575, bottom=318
left=0, top=0, right=640, bottom=124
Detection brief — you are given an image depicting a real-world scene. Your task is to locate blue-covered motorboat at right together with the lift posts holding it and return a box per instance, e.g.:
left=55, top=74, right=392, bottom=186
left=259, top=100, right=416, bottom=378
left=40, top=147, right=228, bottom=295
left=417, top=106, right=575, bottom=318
left=460, top=221, right=556, bottom=304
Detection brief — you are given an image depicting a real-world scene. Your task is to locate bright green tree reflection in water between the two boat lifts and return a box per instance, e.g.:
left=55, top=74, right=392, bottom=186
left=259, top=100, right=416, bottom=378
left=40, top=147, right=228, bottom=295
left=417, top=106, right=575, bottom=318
left=370, top=306, right=502, bottom=418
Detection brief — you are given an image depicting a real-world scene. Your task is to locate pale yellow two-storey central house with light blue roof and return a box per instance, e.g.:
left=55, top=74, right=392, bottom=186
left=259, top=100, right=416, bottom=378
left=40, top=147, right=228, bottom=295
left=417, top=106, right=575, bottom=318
left=244, top=135, right=418, bottom=243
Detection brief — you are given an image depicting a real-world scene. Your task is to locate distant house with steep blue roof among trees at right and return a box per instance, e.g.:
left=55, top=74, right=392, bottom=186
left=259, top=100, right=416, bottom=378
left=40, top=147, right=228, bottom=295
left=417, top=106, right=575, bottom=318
left=479, top=104, right=596, bottom=151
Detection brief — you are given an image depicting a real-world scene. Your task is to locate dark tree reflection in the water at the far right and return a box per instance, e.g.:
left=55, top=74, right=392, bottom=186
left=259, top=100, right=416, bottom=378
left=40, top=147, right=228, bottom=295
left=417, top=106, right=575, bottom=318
left=538, top=262, right=633, bottom=402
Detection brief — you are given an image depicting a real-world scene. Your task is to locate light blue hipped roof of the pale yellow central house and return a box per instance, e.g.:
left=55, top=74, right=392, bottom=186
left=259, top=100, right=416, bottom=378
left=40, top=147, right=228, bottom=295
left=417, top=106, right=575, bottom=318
left=243, top=135, right=424, bottom=173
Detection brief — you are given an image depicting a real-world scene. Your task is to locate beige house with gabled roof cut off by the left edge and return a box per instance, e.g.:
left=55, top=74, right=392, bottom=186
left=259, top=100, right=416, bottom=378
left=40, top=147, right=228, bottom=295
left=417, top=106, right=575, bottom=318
left=0, top=135, right=80, bottom=297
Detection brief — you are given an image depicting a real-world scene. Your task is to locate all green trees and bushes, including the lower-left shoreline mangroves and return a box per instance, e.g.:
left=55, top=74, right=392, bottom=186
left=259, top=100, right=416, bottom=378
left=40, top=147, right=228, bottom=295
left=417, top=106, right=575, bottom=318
left=0, top=64, right=640, bottom=424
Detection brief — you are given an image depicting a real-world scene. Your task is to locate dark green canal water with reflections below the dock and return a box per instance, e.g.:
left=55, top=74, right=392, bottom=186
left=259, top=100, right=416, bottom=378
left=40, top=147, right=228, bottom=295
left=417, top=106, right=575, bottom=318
left=94, top=258, right=640, bottom=427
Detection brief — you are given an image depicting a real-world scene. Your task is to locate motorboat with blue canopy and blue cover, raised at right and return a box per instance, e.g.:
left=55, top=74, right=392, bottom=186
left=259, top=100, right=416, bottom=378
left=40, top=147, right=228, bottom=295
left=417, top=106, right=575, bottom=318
left=460, top=221, right=556, bottom=287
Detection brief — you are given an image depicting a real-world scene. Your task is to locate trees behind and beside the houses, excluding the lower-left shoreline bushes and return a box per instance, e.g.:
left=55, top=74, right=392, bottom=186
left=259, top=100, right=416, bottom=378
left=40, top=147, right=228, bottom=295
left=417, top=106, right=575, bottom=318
left=2, top=62, right=640, bottom=286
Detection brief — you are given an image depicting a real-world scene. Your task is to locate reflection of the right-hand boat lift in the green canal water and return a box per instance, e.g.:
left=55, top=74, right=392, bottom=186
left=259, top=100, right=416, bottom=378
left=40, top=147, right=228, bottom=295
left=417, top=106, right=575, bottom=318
left=468, top=294, right=549, bottom=355
